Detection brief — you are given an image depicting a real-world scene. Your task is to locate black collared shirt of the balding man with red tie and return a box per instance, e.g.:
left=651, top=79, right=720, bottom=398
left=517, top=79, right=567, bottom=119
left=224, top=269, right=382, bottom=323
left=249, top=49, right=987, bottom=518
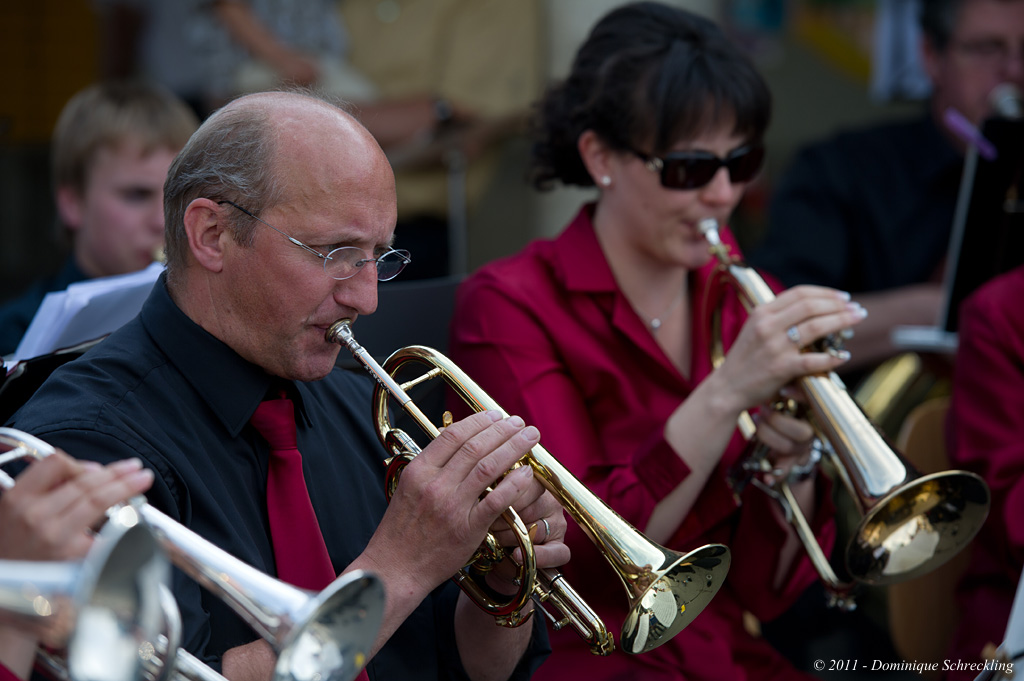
left=10, top=275, right=548, bottom=679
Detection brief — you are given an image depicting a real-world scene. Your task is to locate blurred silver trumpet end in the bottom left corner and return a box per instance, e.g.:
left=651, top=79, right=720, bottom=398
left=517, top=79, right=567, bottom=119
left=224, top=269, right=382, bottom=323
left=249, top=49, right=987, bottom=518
left=0, top=514, right=170, bottom=681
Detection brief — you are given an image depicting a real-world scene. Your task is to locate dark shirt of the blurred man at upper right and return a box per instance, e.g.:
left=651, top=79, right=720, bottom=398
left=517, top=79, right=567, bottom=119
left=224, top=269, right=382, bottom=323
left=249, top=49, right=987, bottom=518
left=748, top=116, right=963, bottom=294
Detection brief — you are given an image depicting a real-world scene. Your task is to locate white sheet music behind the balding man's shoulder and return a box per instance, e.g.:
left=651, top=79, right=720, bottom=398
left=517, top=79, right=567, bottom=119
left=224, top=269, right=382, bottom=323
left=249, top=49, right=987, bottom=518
left=8, top=262, right=164, bottom=365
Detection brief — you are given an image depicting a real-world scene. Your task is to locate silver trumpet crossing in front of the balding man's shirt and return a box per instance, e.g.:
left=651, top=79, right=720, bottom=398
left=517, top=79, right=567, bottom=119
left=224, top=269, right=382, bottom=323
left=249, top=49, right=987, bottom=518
left=0, top=428, right=384, bottom=681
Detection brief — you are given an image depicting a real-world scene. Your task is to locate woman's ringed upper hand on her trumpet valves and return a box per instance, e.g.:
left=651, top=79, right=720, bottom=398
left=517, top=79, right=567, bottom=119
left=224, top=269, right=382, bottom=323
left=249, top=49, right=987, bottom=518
left=716, top=286, right=866, bottom=414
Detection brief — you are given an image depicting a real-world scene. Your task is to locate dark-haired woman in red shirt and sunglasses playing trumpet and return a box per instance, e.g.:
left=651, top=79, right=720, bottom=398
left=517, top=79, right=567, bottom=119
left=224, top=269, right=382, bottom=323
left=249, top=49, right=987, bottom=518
left=452, top=2, right=864, bottom=681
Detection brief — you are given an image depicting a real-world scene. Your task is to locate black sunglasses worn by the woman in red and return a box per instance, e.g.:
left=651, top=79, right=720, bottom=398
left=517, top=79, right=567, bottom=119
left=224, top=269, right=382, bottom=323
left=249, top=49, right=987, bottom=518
left=633, top=144, right=765, bottom=189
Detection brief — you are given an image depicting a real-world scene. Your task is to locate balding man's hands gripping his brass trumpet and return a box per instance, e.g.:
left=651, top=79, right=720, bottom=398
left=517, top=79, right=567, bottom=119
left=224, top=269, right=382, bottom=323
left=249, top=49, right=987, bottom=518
left=342, top=412, right=569, bottom=652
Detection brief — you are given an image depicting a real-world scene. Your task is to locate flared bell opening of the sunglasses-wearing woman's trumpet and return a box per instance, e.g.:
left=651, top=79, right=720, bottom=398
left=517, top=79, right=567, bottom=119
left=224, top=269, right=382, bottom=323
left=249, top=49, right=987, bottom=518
left=846, top=470, right=989, bottom=586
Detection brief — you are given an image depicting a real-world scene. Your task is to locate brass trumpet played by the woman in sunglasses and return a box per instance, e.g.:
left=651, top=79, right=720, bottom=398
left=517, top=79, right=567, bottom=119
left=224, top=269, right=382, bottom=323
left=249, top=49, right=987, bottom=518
left=698, top=218, right=990, bottom=609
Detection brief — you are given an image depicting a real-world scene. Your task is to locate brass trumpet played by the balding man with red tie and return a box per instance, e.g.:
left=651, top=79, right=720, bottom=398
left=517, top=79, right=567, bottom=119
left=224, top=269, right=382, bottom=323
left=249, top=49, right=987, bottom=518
left=326, top=318, right=730, bottom=654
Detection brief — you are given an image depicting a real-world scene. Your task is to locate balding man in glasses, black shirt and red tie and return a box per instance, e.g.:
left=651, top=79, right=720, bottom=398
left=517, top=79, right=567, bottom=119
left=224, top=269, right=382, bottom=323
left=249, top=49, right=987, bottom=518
left=11, top=92, right=568, bottom=681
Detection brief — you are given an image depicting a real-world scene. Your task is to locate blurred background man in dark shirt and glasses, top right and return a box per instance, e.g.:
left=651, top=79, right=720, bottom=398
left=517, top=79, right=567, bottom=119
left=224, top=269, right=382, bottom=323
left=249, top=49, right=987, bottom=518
left=749, top=0, right=1024, bottom=376
